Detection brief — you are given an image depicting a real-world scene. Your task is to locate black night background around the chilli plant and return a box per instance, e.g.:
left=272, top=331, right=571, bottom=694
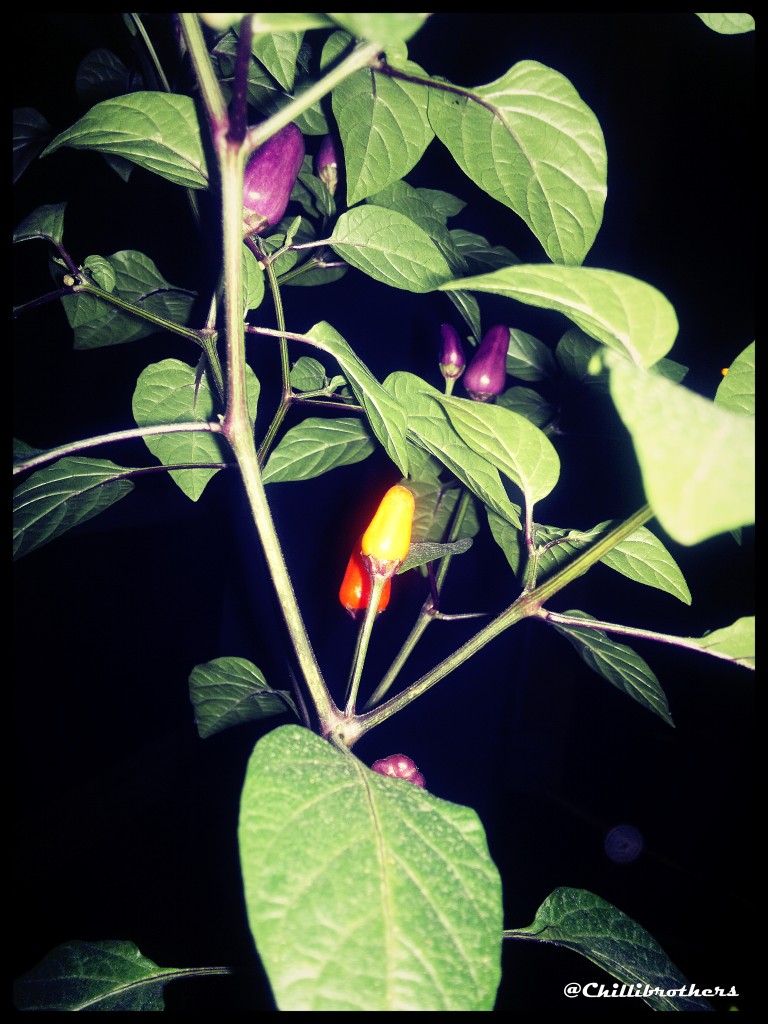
left=11, top=12, right=756, bottom=1019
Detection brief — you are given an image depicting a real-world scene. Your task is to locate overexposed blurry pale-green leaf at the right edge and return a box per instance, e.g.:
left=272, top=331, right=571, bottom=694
left=608, top=358, right=755, bottom=545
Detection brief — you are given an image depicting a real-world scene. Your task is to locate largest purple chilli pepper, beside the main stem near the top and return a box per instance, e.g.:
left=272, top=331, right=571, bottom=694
left=243, top=122, right=304, bottom=234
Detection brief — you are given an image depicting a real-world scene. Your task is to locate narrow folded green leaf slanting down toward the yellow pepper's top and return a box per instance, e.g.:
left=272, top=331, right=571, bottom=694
left=306, top=321, right=408, bottom=476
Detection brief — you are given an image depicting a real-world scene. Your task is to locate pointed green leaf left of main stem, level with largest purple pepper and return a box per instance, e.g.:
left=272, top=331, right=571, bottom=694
left=41, top=92, right=208, bottom=188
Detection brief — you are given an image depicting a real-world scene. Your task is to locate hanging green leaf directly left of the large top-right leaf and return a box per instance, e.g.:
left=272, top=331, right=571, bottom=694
left=332, top=61, right=434, bottom=206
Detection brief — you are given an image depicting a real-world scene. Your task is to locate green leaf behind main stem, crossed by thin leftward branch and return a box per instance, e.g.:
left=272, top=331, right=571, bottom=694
left=133, top=359, right=259, bottom=502
